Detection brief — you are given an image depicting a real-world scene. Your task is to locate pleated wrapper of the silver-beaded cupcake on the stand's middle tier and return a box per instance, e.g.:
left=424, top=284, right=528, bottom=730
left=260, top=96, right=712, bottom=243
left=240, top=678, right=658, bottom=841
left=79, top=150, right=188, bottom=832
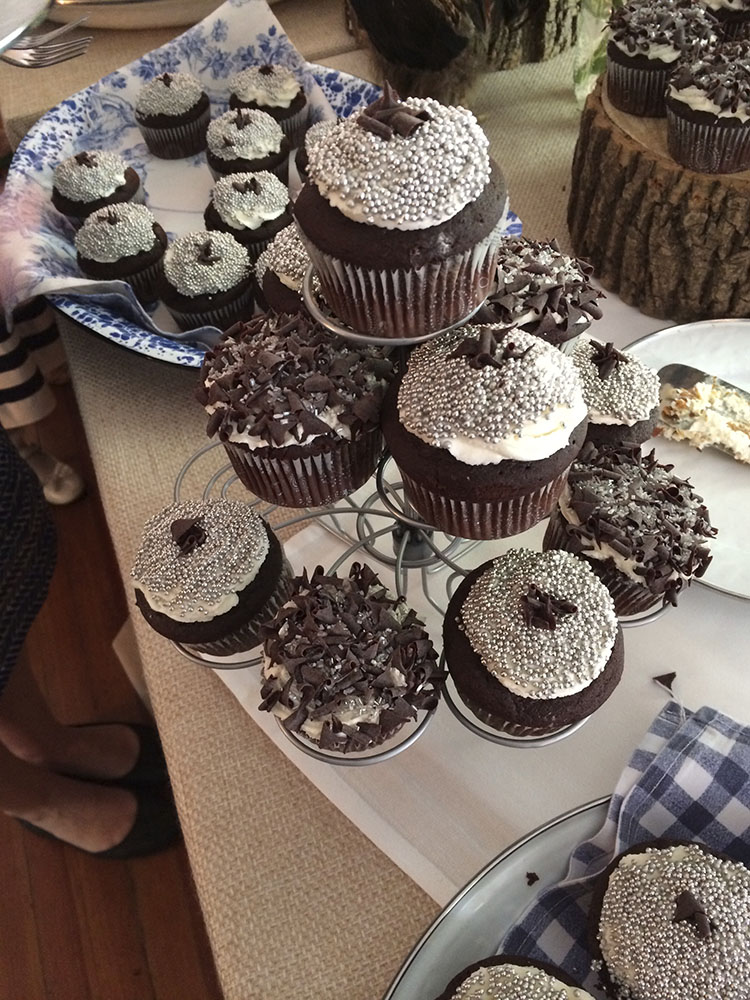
left=400, top=469, right=568, bottom=539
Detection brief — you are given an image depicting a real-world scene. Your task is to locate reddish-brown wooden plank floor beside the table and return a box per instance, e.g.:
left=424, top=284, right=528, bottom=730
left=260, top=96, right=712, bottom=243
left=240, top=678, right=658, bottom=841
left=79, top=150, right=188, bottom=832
left=0, top=386, right=221, bottom=1000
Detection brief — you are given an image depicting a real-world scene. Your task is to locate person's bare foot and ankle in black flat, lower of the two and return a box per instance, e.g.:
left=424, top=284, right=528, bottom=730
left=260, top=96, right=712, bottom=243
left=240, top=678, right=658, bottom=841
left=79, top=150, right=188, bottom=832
left=0, top=740, right=138, bottom=851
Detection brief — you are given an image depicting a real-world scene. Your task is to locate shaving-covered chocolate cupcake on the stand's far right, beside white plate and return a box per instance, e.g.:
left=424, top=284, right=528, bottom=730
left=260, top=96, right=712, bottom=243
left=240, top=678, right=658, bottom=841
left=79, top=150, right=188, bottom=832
left=544, top=444, right=716, bottom=616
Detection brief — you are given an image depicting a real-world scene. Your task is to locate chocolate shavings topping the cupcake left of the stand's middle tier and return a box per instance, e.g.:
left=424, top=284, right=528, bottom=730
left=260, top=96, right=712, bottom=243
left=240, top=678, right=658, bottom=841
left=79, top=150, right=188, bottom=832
left=196, top=314, right=393, bottom=447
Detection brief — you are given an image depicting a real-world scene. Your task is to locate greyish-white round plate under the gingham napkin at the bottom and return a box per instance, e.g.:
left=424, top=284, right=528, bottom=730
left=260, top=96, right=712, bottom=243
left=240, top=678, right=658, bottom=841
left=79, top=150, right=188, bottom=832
left=383, top=796, right=609, bottom=1000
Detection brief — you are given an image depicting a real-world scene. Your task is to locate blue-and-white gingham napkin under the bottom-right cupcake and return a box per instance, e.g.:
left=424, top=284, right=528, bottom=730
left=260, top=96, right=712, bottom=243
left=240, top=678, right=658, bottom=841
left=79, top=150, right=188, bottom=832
left=499, top=701, right=750, bottom=996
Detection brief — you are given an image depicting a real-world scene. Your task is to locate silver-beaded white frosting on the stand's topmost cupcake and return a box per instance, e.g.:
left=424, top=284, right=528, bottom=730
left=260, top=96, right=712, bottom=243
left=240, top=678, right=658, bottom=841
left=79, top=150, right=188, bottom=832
left=307, top=98, right=490, bottom=230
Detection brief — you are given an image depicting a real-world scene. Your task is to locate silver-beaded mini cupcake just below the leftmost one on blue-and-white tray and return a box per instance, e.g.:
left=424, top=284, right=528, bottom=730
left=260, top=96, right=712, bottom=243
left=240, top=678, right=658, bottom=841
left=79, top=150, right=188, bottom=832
left=75, top=202, right=167, bottom=302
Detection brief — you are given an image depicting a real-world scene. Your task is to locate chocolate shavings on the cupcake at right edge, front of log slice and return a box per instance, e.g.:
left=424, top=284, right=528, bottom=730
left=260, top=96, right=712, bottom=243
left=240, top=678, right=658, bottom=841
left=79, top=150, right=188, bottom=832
left=670, top=41, right=750, bottom=115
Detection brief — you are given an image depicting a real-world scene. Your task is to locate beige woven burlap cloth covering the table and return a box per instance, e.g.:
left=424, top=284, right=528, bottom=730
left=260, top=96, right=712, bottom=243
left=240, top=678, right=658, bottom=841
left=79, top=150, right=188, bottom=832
left=44, top=39, right=578, bottom=1000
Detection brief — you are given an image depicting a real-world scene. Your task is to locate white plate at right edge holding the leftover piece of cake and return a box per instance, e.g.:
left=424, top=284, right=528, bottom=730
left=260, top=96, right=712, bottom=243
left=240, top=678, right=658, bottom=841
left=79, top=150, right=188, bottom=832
left=627, top=319, right=750, bottom=598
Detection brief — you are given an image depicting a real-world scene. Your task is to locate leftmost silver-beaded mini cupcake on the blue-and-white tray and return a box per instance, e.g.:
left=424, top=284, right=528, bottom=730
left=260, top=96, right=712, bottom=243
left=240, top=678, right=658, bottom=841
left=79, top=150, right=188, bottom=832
left=52, top=149, right=143, bottom=224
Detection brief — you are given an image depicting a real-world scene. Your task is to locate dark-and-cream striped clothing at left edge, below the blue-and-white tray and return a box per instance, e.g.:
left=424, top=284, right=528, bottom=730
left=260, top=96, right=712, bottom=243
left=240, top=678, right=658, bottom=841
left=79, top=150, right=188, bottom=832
left=0, top=298, right=65, bottom=430
